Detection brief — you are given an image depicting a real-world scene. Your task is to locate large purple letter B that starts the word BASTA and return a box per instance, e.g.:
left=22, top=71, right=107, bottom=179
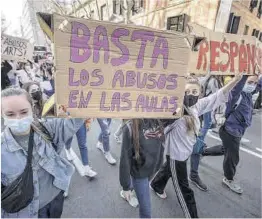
left=70, top=21, right=91, bottom=63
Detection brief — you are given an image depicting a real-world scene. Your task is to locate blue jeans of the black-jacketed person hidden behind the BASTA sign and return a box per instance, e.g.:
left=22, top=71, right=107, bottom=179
left=132, top=177, right=151, bottom=218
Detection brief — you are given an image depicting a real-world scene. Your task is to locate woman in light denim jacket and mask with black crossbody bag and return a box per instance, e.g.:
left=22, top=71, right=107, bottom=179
left=1, top=88, right=83, bottom=218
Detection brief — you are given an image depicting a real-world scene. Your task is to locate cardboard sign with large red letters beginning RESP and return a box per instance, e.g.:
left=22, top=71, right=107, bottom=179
left=189, top=31, right=262, bottom=75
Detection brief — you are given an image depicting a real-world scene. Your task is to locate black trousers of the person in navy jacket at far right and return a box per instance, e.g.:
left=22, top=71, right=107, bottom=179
left=219, top=126, right=241, bottom=180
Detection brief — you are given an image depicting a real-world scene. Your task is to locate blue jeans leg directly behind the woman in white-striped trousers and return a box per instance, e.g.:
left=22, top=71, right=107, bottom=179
left=190, top=112, right=212, bottom=178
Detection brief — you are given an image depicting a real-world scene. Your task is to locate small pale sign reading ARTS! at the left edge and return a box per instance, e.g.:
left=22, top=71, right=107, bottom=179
left=1, top=34, right=33, bottom=61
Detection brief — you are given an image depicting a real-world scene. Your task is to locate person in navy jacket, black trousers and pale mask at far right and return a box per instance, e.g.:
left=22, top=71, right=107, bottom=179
left=219, top=75, right=258, bottom=194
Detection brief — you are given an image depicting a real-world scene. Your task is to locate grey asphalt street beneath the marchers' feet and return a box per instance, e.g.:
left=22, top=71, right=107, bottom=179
left=62, top=112, right=262, bottom=218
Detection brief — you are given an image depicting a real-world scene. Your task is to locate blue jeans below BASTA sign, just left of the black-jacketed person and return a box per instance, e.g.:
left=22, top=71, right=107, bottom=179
left=97, top=118, right=112, bottom=152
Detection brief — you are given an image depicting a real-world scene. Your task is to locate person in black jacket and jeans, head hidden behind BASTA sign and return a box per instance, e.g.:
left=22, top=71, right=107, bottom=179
left=119, top=119, right=164, bottom=218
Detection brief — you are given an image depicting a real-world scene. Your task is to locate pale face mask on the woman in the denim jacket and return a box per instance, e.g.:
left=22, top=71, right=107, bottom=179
left=4, top=115, right=34, bottom=135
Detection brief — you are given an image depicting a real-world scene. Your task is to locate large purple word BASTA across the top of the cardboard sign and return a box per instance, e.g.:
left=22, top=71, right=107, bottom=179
left=70, top=21, right=169, bottom=69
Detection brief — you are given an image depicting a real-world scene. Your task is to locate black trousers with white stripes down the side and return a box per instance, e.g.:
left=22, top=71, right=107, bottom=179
left=151, top=156, right=198, bottom=218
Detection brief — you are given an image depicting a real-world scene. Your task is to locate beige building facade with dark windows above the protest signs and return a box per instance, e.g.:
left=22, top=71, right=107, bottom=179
left=64, top=0, right=262, bottom=41
